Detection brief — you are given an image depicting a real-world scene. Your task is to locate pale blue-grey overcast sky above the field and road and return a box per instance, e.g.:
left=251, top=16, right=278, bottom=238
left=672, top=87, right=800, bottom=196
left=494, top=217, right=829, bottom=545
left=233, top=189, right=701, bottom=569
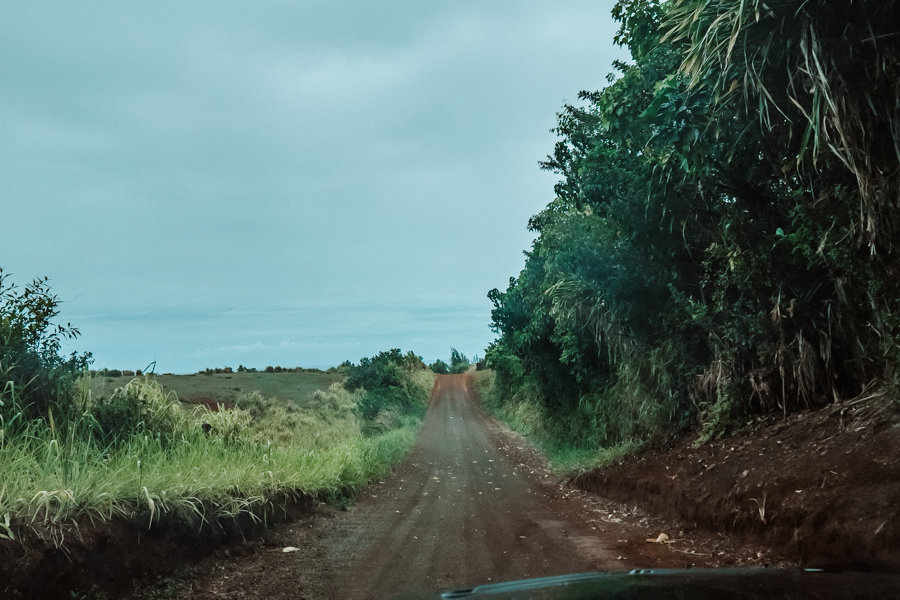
left=0, top=0, right=624, bottom=373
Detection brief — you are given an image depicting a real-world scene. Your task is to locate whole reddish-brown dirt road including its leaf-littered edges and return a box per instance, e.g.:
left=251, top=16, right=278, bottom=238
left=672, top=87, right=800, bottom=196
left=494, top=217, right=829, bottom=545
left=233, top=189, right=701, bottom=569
left=149, top=375, right=761, bottom=598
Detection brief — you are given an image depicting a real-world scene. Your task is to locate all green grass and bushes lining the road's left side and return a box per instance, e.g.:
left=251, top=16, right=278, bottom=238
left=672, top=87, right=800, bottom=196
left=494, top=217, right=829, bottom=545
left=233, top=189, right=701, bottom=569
left=0, top=271, right=433, bottom=543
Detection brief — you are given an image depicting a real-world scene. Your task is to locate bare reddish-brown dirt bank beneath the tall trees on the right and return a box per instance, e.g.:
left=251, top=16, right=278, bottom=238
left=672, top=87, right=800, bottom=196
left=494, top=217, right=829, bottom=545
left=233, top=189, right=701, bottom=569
left=573, top=394, right=900, bottom=567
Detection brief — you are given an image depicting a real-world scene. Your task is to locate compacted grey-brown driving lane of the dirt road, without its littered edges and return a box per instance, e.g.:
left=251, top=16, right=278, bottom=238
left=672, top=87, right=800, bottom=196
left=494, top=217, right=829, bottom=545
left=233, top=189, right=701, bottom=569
left=330, top=375, right=621, bottom=598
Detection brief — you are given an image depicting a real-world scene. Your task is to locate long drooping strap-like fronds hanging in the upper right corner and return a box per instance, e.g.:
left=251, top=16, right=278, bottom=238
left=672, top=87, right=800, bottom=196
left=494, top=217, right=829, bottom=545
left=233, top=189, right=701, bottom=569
left=667, top=0, right=900, bottom=254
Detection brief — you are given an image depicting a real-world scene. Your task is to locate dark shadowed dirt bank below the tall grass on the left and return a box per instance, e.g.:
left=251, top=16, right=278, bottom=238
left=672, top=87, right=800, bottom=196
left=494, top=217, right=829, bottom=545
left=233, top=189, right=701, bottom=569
left=0, top=498, right=318, bottom=599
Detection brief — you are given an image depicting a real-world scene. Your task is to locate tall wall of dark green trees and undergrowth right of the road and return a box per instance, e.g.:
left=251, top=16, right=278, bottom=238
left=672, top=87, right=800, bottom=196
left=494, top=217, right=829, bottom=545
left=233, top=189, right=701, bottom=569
left=479, top=0, right=900, bottom=464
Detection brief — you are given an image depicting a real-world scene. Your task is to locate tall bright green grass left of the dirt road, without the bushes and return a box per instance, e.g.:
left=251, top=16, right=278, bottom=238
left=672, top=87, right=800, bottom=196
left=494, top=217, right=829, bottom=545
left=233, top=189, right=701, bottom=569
left=0, top=372, right=431, bottom=538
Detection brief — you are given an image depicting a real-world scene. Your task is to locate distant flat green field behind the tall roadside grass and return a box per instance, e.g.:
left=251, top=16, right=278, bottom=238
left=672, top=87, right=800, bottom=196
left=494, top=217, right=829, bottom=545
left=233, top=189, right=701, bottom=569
left=90, top=371, right=342, bottom=406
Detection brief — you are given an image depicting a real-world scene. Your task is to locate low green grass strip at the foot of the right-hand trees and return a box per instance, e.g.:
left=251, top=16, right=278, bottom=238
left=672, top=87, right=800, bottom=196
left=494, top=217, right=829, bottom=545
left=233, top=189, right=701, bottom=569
left=472, top=370, right=642, bottom=474
